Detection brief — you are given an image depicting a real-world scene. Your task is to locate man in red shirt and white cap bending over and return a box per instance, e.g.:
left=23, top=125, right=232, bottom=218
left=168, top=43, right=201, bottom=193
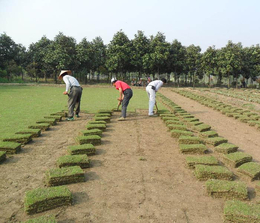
left=111, top=78, right=133, bottom=121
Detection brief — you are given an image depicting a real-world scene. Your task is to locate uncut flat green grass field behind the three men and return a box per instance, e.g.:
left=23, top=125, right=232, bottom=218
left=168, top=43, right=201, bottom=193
left=0, top=85, right=165, bottom=140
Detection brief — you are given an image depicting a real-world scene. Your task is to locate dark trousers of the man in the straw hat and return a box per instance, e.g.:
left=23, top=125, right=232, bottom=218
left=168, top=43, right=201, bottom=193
left=68, top=87, right=82, bottom=118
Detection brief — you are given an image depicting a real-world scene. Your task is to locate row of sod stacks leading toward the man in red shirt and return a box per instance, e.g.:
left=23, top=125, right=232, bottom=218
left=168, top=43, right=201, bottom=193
left=24, top=110, right=112, bottom=223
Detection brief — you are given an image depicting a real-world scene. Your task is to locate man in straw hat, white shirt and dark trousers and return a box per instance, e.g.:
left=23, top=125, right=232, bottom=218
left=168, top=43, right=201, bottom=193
left=58, top=70, right=82, bottom=121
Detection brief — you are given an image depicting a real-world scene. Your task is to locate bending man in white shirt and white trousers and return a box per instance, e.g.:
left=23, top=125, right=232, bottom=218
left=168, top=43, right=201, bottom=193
left=146, top=78, right=167, bottom=117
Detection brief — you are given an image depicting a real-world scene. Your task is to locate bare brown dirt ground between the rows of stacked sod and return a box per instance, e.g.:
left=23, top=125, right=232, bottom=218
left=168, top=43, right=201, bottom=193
left=0, top=88, right=260, bottom=223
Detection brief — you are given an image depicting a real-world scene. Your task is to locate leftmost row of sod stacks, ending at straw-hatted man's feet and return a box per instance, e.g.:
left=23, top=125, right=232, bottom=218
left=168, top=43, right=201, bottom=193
left=0, top=112, right=67, bottom=166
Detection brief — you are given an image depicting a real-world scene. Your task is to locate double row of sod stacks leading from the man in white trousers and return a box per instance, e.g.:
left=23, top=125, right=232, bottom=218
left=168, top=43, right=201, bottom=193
left=158, top=94, right=260, bottom=222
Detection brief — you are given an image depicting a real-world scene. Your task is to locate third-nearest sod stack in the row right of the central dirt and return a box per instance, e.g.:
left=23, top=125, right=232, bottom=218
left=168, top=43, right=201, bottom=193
left=194, top=165, right=233, bottom=180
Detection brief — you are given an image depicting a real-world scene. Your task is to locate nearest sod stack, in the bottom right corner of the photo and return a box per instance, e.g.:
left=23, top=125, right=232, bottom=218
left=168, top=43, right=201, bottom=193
left=224, top=200, right=260, bottom=223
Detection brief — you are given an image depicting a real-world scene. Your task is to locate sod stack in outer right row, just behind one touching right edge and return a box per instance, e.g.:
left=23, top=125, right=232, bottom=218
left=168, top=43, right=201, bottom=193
left=223, top=152, right=253, bottom=167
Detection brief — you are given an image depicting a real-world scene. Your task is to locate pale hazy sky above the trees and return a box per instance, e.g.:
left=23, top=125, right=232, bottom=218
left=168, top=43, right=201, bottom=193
left=0, top=0, right=260, bottom=52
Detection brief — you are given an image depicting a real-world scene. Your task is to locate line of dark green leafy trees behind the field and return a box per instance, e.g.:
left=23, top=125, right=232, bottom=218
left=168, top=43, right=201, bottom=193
left=0, top=30, right=260, bottom=86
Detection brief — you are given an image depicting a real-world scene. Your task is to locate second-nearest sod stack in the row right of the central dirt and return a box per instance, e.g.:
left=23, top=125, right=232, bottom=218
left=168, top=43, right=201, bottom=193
left=206, top=179, right=248, bottom=200
